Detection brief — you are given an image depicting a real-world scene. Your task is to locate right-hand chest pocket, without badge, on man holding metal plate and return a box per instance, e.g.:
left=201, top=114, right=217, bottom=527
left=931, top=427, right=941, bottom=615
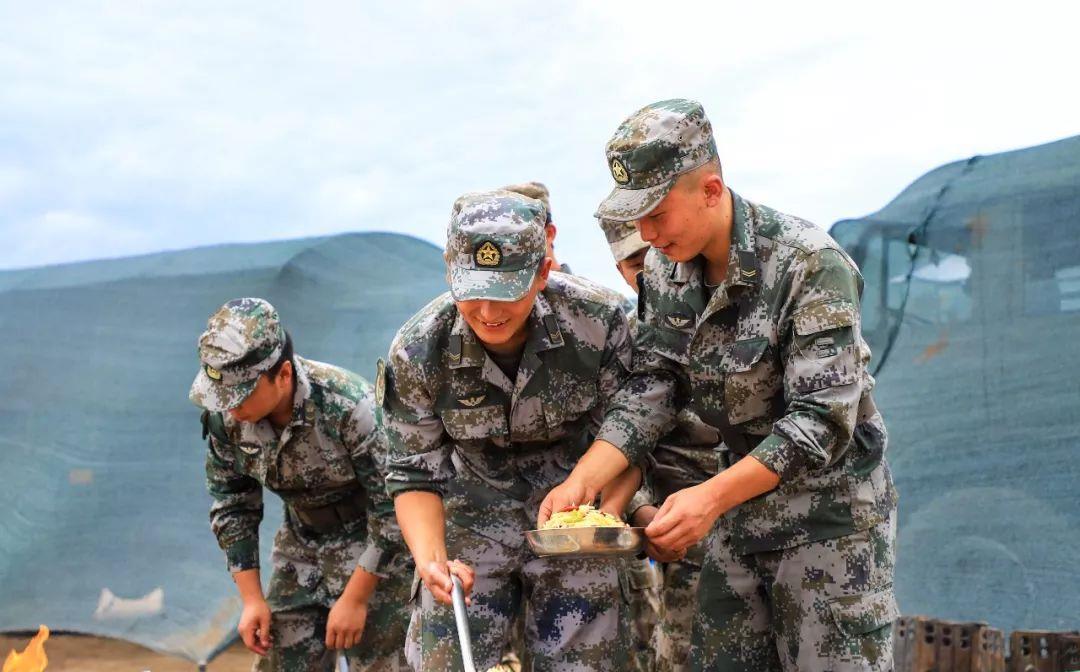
left=720, top=336, right=783, bottom=425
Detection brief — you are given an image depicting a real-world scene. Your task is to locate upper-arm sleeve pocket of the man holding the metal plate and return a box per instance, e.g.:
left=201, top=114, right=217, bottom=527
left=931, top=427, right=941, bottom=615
left=789, top=301, right=862, bottom=394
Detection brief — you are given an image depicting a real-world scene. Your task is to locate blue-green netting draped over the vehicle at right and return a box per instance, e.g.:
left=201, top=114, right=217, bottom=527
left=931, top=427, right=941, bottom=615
left=832, top=136, right=1080, bottom=630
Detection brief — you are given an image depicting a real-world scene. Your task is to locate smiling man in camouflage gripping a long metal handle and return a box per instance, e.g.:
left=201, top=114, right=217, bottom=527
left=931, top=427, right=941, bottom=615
left=377, top=191, right=649, bottom=672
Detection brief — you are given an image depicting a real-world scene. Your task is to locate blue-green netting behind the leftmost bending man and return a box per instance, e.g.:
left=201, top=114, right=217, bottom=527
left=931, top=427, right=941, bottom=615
left=0, top=233, right=446, bottom=661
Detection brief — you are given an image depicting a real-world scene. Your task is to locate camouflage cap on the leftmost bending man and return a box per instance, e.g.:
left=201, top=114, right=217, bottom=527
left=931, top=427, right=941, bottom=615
left=188, top=298, right=285, bottom=411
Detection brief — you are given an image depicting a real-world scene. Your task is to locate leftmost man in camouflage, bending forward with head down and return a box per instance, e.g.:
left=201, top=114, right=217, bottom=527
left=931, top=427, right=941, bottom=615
left=190, top=298, right=413, bottom=672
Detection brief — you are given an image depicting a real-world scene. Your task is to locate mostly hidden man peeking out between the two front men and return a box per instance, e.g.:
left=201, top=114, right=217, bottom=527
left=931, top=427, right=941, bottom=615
left=599, top=219, right=721, bottom=672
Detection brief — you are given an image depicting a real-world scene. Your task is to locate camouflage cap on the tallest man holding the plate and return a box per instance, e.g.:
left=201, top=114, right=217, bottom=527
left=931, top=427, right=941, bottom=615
left=596, top=98, right=717, bottom=221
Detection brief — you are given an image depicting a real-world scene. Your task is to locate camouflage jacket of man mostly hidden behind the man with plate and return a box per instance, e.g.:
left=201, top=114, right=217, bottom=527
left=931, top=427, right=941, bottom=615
left=626, top=313, right=723, bottom=519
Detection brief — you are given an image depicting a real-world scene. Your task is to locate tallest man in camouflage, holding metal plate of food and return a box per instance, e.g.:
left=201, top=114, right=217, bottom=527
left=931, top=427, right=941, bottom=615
left=543, top=99, right=896, bottom=671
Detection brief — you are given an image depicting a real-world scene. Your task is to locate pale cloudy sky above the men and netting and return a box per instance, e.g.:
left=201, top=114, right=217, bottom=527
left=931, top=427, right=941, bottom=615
left=0, top=0, right=1080, bottom=286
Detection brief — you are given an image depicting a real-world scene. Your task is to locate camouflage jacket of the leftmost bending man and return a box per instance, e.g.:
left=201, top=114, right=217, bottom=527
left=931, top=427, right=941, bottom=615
left=206, top=357, right=404, bottom=576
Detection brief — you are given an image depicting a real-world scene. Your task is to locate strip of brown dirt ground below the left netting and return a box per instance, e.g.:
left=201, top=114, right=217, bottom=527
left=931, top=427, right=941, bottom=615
left=0, top=633, right=255, bottom=672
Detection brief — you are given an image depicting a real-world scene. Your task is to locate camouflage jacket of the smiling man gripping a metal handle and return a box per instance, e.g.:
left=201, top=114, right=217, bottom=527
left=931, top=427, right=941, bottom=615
left=383, top=272, right=662, bottom=547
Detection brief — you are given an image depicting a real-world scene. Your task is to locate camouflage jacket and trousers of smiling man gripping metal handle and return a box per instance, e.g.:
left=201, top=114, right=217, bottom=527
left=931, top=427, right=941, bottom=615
left=383, top=272, right=661, bottom=670
